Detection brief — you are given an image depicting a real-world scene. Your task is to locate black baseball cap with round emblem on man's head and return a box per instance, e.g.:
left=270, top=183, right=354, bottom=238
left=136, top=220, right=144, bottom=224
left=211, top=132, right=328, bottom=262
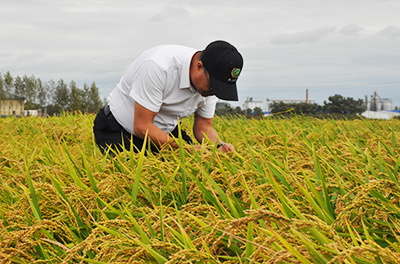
left=201, top=40, right=243, bottom=101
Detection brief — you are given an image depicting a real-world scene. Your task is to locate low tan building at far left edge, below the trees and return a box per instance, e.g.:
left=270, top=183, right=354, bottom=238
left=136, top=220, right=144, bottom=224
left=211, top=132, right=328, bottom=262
left=0, top=92, right=25, bottom=117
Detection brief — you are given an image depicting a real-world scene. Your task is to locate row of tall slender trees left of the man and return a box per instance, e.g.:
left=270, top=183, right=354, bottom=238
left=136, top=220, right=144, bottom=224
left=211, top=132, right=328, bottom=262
left=0, top=72, right=103, bottom=115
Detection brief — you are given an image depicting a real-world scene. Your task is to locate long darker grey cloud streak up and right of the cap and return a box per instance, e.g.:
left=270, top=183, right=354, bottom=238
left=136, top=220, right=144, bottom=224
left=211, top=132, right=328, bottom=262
left=270, top=26, right=336, bottom=44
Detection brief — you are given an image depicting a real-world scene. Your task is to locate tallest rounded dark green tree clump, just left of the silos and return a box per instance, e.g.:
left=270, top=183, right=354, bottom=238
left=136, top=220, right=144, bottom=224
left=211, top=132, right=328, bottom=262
left=323, top=94, right=365, bottom=115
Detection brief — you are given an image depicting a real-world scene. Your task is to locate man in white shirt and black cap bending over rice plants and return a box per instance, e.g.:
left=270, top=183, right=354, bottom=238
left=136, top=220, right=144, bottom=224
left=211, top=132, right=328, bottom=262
left=93, top=40, right=243, bottom=154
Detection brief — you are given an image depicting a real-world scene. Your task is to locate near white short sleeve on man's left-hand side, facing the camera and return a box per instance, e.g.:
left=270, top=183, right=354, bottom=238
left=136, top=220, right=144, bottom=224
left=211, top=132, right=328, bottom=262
left=129, top=60, right=166, bottom=113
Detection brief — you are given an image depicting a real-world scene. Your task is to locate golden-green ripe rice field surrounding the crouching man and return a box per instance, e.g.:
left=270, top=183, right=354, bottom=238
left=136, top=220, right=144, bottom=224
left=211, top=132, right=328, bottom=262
left=0, top=115, right=400, bottom=264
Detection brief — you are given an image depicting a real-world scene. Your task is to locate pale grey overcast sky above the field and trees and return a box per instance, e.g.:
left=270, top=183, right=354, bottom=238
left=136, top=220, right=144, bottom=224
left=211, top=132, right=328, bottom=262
left=0, top=0, right=400, bottom=109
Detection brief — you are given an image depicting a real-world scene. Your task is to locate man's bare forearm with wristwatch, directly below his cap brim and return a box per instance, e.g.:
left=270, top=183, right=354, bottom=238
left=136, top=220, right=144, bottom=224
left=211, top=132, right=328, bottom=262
left=193, top=113, right=235, bottom=152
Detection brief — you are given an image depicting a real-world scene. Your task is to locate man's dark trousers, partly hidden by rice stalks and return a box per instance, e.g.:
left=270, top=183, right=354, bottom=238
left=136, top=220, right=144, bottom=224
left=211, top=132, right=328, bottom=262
left=93, top=105, right=193, bottom=156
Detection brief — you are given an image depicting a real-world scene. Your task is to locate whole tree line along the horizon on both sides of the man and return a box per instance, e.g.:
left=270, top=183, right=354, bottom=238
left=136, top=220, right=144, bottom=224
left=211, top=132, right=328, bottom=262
left=0, top=72, right=372, bottom=117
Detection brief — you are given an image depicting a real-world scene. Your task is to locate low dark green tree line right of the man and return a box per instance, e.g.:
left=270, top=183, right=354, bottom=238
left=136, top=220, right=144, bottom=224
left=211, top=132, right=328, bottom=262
left=216, top=94, right=365, bottom=117
